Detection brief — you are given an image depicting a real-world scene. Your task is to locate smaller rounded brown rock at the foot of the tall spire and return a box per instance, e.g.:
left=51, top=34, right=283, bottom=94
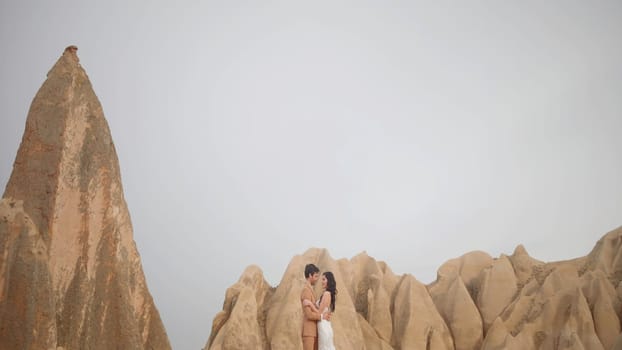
left=0, top=199, right=57, bottom=349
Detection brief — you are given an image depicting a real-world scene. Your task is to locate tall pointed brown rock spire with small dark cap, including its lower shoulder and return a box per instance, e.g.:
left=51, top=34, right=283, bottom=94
left=0, top=47, right=170, bottom=350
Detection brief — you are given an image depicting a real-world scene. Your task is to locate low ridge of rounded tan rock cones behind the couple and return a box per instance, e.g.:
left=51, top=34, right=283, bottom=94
left=205, top=227, right=622, bottom=350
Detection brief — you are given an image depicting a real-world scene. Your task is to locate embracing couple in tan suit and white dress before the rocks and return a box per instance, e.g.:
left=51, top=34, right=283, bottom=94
left=300, top=264, right=337, bottom=350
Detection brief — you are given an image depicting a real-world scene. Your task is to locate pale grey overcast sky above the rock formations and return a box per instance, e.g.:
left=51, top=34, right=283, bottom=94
left=0, top=0, right=622, bottom=349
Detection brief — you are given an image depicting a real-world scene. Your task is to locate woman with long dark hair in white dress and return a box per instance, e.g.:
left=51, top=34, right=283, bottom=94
left=303, top=271, right=337, bottom=350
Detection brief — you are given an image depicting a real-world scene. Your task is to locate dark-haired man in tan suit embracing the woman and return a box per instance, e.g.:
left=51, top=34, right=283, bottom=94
left=300, top=264, right=321, bottom=350
